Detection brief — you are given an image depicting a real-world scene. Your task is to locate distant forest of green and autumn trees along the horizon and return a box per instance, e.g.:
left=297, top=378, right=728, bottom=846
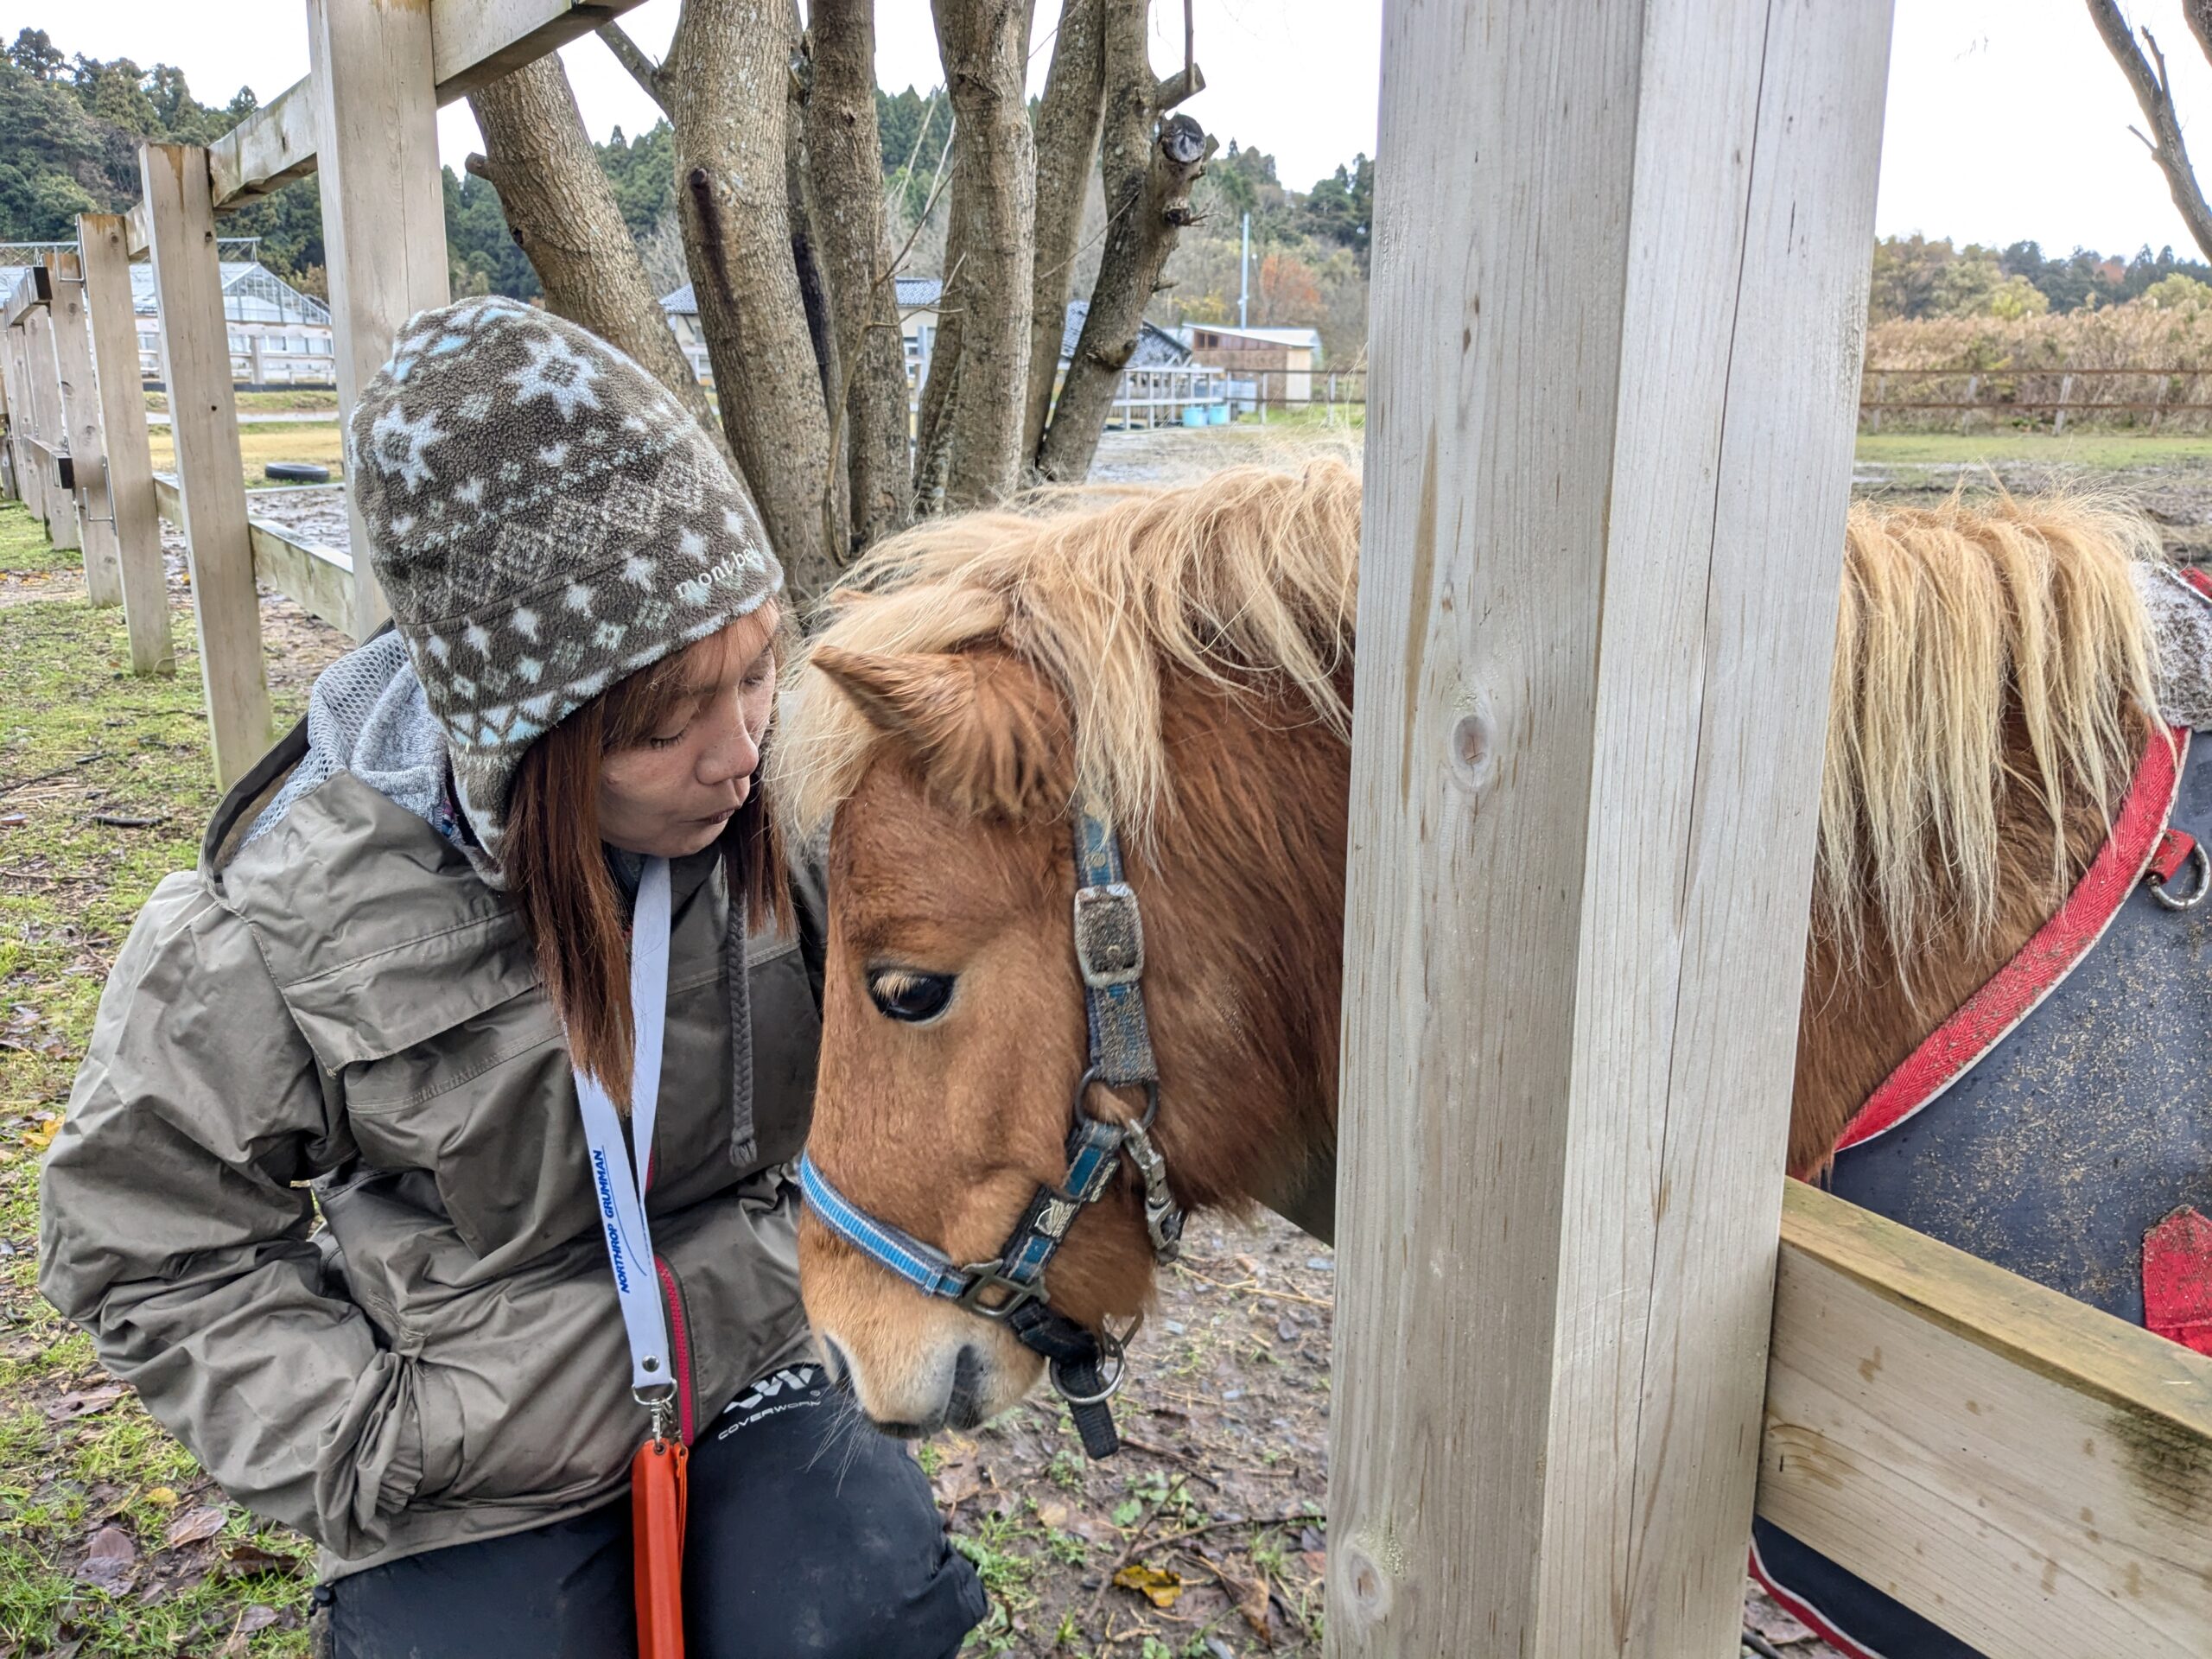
left=0, top=29, right=2212, bottom=367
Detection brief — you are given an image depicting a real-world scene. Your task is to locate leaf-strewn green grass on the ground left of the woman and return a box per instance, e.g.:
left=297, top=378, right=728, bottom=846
left=0, top=542, right=312, bottom=1659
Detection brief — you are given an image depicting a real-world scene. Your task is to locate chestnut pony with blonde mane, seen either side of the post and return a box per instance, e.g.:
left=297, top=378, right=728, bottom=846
left=767, top=462, right=2164, bottom=1435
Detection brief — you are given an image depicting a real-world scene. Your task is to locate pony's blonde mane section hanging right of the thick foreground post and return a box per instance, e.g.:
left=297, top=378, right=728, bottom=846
left=1816, top=495, right=2165, bottom=963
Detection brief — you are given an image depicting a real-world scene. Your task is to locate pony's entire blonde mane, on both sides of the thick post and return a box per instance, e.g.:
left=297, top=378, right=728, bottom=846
left=770, top=460, right=2164, bottom=960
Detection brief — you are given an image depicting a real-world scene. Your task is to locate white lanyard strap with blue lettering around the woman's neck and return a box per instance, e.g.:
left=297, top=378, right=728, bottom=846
left=575, top=858, right=677, bottom=1395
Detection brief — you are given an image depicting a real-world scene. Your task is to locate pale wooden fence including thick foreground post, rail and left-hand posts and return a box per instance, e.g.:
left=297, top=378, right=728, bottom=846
left=0, top=0, right=2212, bottom=1659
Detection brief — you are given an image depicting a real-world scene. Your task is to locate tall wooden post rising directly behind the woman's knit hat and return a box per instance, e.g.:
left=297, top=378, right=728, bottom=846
left=308, top=0, right=449, bottom=637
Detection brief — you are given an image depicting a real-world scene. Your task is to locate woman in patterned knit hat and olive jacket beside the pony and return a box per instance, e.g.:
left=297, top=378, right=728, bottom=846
left=40, top=299, right=984, bottom=1659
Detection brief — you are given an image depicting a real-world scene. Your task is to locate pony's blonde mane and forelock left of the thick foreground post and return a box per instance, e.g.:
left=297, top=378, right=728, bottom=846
left=770, top=460, right=1360, bottom=841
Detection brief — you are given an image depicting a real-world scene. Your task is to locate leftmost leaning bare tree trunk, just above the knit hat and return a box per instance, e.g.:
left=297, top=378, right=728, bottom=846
left=467, top=53, right=730, bottom=455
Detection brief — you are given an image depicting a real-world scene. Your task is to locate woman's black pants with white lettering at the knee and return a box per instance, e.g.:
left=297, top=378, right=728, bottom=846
left=316, top=1365, right=987, bottom=1659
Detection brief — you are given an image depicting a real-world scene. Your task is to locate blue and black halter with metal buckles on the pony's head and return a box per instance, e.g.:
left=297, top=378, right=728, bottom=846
left=798, top=797, right=1184, bottom=1458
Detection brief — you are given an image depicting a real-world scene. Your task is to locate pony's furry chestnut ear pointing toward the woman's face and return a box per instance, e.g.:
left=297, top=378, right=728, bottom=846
left=810, top=646, right=1075, bottom=818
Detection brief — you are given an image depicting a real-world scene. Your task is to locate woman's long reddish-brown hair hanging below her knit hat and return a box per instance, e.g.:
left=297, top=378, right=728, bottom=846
left=500, top=628, right=791, bottom=1110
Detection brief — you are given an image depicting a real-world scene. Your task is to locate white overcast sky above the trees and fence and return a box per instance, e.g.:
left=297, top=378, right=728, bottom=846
left=13, top=0, right=2212, bottom=252
